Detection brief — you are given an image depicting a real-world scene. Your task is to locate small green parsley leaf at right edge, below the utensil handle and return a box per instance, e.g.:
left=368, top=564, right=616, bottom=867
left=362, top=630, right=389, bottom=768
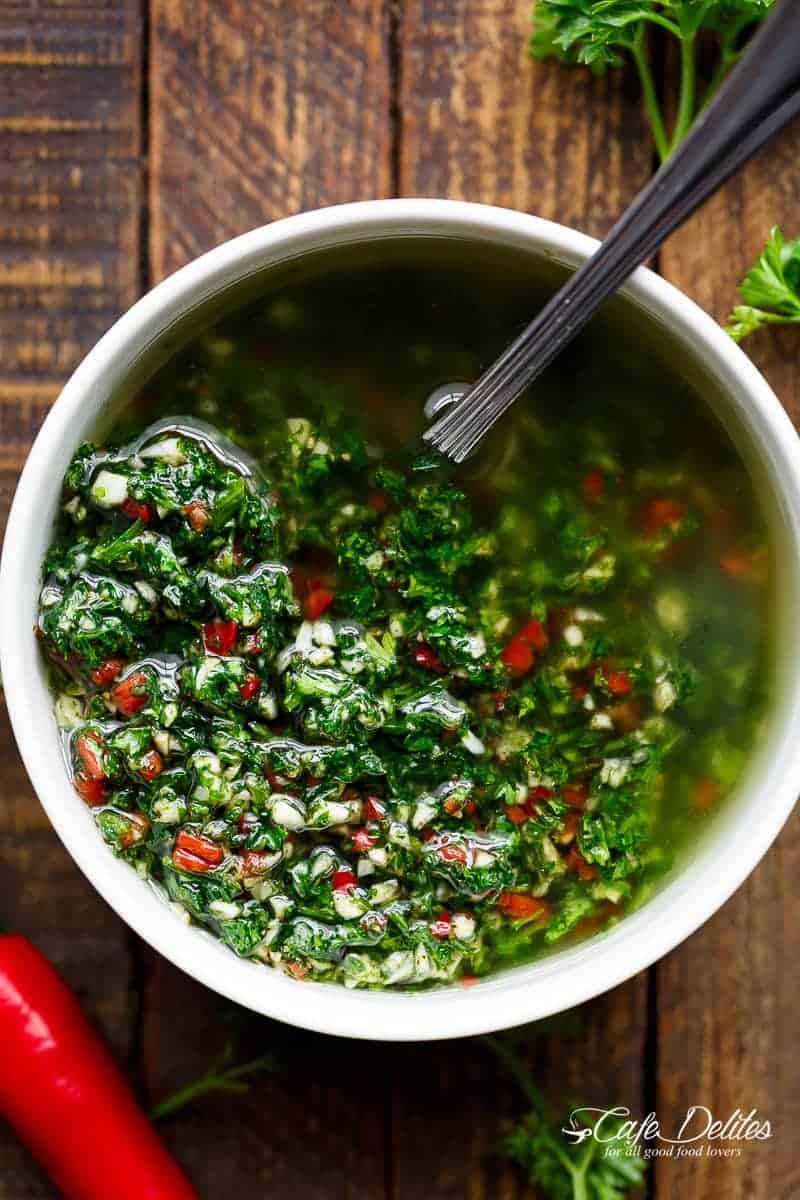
left=726, top=226, right=800, bottom=342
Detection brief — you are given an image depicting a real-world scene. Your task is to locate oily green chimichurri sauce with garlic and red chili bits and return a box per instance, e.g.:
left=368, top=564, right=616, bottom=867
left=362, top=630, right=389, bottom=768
left=38, top=244, right=768, bottom=988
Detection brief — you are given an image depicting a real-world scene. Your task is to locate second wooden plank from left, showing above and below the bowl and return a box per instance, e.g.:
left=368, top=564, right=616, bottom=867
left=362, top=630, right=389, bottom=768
left=143, top=0, right=391, bottom=1200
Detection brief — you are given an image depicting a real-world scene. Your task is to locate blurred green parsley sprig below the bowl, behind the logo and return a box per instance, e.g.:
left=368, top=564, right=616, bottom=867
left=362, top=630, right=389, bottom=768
left=482, top=1036, right=646, bottom=1200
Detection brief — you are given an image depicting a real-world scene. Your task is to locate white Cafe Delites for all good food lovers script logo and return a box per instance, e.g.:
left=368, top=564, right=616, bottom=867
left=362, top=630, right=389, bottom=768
left=561, top=1104, right=772, bottom=1158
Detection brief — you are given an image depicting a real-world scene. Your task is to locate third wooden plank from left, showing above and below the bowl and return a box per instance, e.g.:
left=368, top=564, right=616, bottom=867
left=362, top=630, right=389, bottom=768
left=392, top=0, right=650, bottom=1200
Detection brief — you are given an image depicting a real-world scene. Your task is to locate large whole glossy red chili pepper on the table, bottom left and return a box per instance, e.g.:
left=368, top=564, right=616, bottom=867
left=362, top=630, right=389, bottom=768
left=0, top=934, right=198, bottom=1200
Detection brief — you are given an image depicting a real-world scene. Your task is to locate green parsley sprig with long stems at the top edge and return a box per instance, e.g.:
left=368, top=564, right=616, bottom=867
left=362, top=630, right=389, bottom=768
left=530, top=0, right=772, bottom=162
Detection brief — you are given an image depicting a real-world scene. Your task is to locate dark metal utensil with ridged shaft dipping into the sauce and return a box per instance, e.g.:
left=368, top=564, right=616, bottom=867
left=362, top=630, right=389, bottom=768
left=422, top=0, right=800, bottom=463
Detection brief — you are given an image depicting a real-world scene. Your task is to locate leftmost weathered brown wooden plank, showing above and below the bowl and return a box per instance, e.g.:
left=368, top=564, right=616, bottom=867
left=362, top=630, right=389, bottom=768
left=0, top=0, right=142, bottom=1200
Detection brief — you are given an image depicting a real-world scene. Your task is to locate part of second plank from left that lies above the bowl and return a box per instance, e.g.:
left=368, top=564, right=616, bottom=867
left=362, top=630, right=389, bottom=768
left=150, top=0, right=391, bottom=278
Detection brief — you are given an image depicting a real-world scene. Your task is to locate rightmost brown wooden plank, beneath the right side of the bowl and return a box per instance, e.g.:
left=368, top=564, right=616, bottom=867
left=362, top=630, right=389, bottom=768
left=656, top=128, right=800, bottom=1200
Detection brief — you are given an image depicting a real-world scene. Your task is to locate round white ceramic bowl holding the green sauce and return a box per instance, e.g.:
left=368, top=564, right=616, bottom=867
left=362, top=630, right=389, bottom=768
left=0, top=199, right=800, bottom=1039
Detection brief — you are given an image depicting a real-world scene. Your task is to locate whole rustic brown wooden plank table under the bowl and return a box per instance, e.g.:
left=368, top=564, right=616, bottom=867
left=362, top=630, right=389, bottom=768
left=0, top=0, right=800, bottom=1200
